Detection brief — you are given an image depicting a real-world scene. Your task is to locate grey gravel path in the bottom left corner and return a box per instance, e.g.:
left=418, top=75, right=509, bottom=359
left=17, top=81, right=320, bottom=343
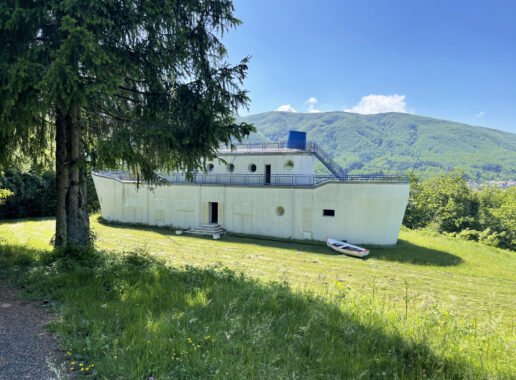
left=0, top=285, right=62, bottom=380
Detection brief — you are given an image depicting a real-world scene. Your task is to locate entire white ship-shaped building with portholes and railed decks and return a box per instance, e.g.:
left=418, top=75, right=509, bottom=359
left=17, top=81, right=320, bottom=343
left=92, top=132, right=410, bottom=245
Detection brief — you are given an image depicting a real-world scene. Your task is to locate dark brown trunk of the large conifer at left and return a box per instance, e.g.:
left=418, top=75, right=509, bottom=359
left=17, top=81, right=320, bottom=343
left=55, top=105, right=90, bottom=247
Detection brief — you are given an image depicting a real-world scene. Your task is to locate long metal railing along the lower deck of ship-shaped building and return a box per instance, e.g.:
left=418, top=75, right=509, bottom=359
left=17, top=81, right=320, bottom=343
left=97, top=172, right=409, bottom=187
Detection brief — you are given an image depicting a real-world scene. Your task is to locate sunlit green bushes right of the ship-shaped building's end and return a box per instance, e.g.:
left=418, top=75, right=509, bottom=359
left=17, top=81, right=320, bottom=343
left=403, top=170, right=516, bottom=250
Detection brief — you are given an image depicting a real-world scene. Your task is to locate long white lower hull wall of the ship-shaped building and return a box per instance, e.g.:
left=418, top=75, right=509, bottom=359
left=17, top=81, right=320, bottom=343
left=93, top=174, right=409, bottom=245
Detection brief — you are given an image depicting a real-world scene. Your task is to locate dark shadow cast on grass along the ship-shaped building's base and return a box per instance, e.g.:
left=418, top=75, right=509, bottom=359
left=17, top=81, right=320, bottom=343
left=94, top=218, right=464, bottom=267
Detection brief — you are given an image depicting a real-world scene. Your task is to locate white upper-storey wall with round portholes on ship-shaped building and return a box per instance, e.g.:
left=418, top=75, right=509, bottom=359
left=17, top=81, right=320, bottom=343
left=207, top=153, right=315, bottom=175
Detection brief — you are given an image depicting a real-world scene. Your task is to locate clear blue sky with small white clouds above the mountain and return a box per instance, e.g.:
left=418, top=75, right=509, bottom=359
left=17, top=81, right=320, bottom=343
left=223, top=0, right=516, bottom=133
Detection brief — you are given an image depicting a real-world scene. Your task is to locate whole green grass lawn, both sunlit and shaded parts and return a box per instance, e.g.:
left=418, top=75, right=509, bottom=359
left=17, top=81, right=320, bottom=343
left=0, top=216, right=516, bottom=379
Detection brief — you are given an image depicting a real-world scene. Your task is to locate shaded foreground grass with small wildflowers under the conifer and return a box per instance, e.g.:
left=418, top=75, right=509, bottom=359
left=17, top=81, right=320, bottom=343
left=0, top=245, right=485, bottom=379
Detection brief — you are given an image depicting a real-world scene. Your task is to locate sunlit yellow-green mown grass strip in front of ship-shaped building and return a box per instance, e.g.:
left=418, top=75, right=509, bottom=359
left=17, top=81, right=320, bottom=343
left=0, top=216, right=516, bottom=318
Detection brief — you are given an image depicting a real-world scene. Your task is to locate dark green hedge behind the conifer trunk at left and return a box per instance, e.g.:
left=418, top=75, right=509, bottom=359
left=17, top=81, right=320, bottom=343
left=0, top=172, right=100, bottom=219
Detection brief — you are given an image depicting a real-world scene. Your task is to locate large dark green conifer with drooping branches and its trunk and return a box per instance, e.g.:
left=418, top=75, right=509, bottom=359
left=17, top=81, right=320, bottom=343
left=0, top=0, right=253, bottom=245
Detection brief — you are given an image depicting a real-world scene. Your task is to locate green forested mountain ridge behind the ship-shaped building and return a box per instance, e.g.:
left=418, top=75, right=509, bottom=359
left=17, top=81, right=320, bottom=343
left=237, top=112, right=516, bottom=181
